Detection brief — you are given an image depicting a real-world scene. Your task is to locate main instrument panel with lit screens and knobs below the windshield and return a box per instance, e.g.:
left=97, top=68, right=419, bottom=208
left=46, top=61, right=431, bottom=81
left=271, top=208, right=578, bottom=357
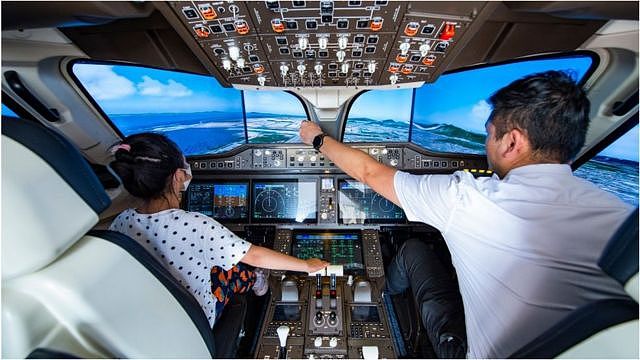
left=185, top=143, right=491, bottom=226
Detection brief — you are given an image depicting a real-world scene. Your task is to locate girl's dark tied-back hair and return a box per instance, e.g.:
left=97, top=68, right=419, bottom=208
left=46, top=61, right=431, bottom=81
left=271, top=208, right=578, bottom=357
left=109, top=133, right=184, bottom=200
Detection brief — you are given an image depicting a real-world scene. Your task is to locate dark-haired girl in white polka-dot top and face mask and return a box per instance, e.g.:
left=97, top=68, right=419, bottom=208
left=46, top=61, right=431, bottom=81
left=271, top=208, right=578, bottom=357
left=110, top=133, right=328, bottom=326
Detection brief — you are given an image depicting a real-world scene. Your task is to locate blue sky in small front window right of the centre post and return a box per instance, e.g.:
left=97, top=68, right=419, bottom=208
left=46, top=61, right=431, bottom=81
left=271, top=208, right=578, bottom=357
left=349, top=89, right=413, bottom=123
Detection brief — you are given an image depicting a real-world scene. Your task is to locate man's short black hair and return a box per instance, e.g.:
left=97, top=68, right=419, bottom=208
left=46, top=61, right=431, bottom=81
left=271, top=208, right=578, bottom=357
left=489, top=71, right=590, bottom=163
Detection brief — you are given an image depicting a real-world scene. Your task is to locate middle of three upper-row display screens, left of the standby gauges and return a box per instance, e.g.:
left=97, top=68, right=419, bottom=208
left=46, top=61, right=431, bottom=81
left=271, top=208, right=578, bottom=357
left=252, top=180, right=317, bottom=223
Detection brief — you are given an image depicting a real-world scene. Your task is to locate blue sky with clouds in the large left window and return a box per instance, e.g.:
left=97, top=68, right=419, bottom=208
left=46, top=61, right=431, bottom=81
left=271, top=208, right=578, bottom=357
left=73, top=63, right=242, bottom=114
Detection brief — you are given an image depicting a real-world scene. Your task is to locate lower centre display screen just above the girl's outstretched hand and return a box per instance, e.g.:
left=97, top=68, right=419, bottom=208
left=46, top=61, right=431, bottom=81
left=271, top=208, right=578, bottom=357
left=292, top=231, right=364, bottom=275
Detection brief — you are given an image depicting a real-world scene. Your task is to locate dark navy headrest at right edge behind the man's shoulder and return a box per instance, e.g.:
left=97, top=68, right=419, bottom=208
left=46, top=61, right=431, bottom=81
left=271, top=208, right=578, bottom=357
left=598, top=208, right=638, bottom=286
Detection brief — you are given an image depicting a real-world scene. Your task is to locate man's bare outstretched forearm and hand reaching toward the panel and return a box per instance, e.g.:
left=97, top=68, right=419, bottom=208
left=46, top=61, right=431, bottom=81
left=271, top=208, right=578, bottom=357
left=300, top=120, right=400, bottom=206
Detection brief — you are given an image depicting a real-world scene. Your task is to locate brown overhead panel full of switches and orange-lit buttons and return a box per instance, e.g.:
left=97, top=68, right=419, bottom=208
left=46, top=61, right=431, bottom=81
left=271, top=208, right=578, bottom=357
left=170, top=1, right=485, bottom=88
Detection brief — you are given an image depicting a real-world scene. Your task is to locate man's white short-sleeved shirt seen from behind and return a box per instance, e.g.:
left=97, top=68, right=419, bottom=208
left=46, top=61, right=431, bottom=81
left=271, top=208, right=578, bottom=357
left=394, top=164, right=632, bottom=358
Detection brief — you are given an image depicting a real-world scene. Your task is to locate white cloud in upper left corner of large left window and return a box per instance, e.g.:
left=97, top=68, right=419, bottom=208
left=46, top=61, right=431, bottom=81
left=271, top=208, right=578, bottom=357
left=73, top=64, right=136, bottom=100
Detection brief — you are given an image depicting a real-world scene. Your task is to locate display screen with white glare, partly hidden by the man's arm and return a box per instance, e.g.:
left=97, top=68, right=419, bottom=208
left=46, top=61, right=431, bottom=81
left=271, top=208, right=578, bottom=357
left=338, top=180, right=405, bottom=224
